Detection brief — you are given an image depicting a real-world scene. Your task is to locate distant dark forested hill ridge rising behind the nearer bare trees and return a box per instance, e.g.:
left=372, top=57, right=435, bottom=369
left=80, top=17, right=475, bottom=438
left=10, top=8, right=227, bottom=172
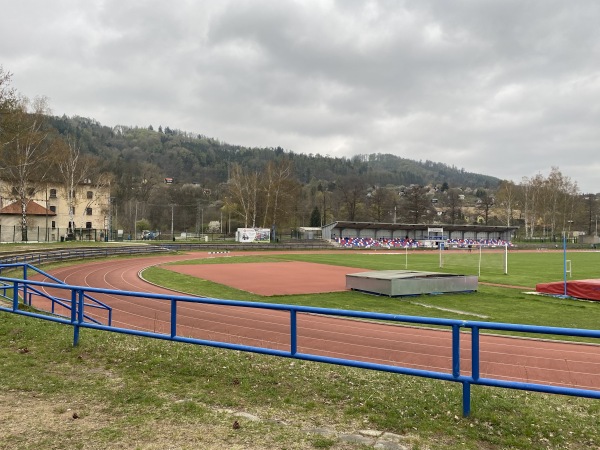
left=50, top=116, right=500, bottom=188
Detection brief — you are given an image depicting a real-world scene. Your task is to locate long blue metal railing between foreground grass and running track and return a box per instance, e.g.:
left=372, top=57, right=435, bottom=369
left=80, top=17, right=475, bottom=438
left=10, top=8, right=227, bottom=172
left=0, top=277, right=600, bottom=416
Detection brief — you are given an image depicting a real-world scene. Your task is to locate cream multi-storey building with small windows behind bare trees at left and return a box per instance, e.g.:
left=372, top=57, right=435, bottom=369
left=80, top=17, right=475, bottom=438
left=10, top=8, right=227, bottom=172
left=0, top=180, right=112, bottom=242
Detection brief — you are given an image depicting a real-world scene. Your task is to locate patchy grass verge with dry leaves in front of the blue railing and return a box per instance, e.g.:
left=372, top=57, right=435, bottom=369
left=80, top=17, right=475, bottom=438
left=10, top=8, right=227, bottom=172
left=0, top=313, right=600, bottom=449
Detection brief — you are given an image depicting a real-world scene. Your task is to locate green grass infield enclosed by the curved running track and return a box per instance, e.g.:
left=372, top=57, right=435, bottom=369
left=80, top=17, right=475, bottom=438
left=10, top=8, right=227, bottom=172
left=143, top=251, right=600, bottom=339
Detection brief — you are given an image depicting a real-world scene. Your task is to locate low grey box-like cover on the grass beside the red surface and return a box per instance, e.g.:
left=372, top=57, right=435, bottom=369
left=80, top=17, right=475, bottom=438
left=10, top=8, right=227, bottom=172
left=346, top=270, right=478, bottom=297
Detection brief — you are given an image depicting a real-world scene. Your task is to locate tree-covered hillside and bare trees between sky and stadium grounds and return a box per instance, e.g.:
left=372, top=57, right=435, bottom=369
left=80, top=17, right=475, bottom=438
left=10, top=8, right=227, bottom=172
left=0, top=67, right=597, bottom=238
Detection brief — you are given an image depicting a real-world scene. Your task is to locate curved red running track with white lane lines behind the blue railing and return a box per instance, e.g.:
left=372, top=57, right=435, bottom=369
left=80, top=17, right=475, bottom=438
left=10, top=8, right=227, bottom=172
left=31, top=253, right=600, bottom=390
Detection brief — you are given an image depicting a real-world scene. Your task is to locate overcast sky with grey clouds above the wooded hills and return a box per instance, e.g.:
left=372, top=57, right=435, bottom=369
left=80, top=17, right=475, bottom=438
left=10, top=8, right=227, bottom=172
left=0, top=0, right=600, bottom=192
